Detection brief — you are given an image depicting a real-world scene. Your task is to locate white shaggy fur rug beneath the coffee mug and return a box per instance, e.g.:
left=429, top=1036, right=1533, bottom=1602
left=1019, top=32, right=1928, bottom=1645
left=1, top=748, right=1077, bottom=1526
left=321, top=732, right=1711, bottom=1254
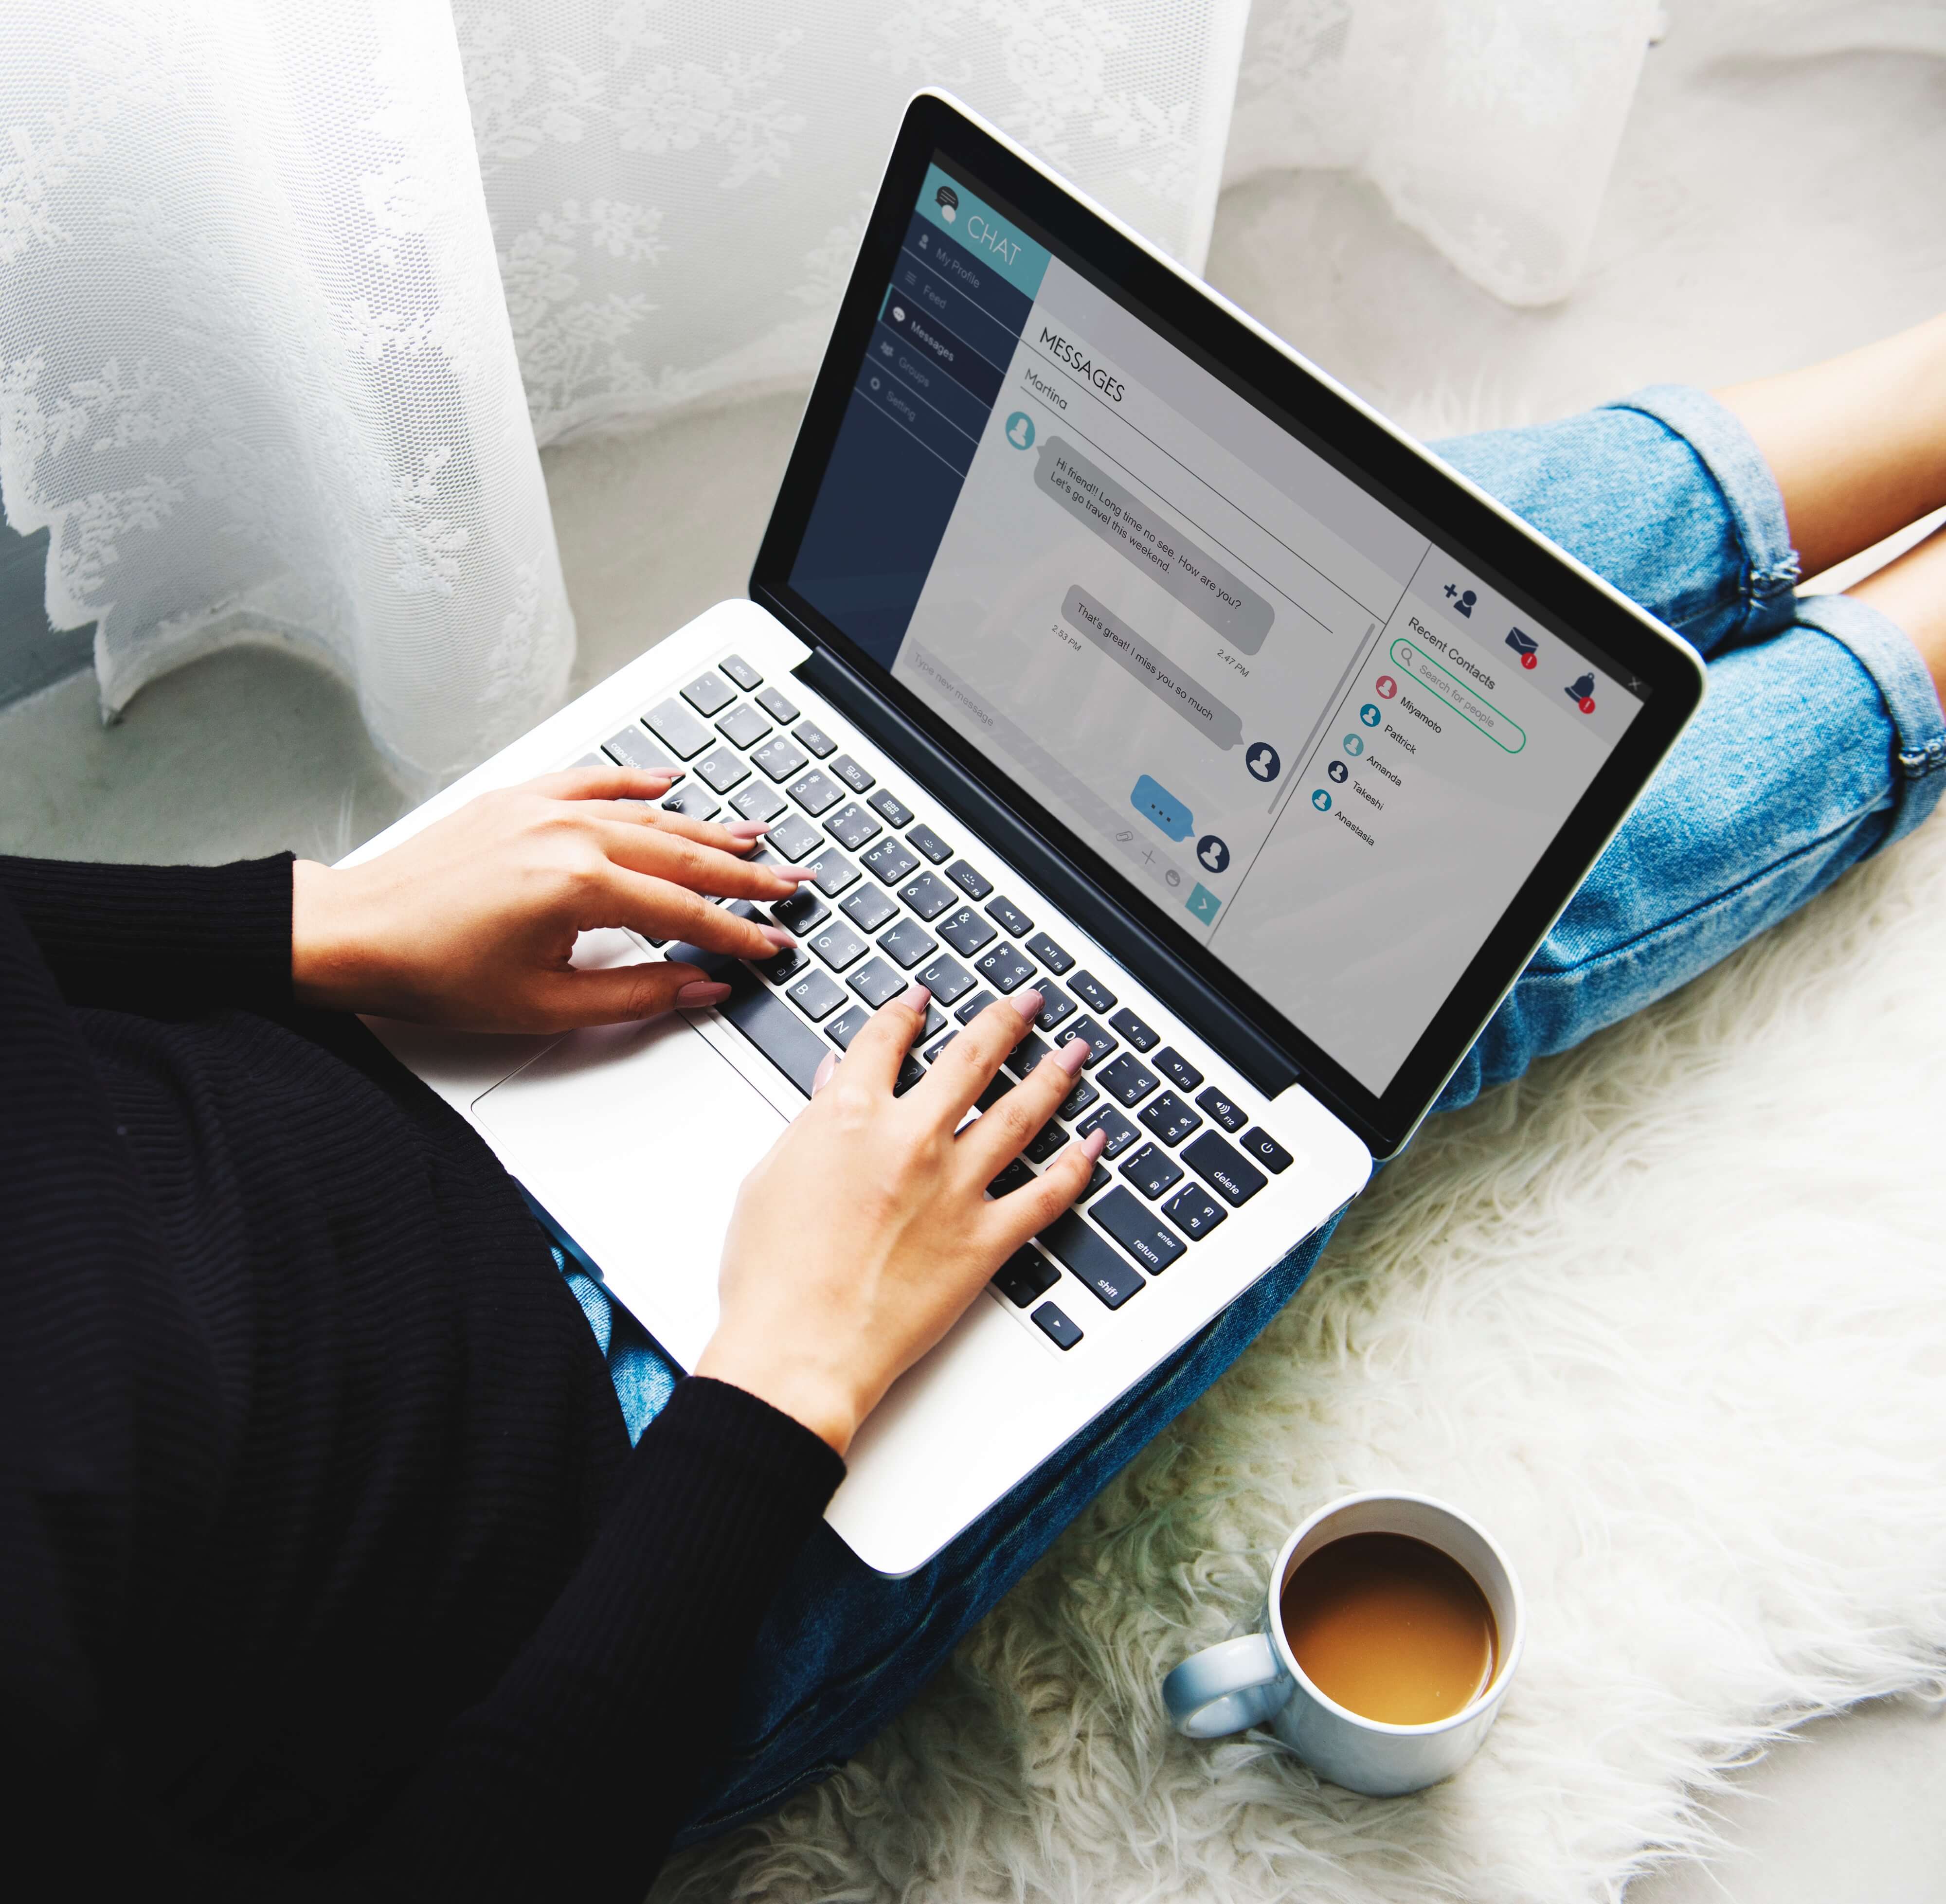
left=656, top=782, right=1946, bottom=1904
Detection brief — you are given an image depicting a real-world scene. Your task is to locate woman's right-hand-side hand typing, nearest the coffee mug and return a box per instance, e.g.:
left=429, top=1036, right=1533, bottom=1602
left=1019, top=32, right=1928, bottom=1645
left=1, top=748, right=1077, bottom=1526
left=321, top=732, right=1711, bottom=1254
left=697, top=985, right=1105, bottom=1455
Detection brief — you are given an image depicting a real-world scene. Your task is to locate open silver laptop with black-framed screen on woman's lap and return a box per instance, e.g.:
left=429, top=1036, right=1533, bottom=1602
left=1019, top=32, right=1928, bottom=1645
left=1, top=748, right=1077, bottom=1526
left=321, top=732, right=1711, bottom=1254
left=354, top=91, right=1703, bottom=1575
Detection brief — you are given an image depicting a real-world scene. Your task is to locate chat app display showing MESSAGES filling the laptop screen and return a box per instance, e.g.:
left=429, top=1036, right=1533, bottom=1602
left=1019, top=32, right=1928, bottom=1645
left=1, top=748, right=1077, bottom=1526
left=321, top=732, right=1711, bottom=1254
left=792, top=165, right=1640, bottom=1092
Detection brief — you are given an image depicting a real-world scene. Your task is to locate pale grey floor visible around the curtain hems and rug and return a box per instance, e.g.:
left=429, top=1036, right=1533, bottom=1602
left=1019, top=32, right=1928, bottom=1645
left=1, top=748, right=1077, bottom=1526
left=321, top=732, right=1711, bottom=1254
left=0, top=11, right=1946, bottom=1904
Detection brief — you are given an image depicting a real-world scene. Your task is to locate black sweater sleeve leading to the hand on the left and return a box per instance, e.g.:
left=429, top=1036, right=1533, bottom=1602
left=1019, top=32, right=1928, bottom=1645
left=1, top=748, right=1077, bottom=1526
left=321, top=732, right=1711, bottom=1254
left=0, top=853, right=294, bottom=1018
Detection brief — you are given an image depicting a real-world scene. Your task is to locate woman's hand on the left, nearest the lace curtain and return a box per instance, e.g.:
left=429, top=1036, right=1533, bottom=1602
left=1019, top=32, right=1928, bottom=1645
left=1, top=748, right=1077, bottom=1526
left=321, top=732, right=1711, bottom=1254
left=290, top=767, right=811, bottom=1032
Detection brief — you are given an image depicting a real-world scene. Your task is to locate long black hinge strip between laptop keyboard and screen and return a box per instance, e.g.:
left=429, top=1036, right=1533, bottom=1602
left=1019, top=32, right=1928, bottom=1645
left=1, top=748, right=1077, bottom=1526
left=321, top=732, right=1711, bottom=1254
left=790, top=634, right=1308, bottom=1110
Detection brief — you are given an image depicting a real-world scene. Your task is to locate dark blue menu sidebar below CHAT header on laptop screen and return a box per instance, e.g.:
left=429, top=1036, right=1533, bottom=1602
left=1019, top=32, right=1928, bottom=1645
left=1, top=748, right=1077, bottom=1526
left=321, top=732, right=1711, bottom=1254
left=790, top=198, right=1045, bottom=668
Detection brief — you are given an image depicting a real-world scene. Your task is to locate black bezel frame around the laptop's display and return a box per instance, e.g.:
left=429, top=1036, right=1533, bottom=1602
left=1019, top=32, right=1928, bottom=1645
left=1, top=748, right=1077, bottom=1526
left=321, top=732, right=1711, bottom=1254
left=749, top=93, right=1705, bottom=1156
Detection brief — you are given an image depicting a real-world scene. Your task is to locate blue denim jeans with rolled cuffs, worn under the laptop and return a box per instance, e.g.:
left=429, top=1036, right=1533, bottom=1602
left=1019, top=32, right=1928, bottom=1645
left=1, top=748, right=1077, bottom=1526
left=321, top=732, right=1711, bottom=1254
left=580, top=387, right=1946, bottom=1844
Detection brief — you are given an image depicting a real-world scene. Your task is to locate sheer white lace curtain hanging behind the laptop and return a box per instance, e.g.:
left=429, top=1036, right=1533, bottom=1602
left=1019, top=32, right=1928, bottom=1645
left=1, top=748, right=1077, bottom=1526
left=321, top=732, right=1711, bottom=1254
left=0, top=0, right=1648, bottom=787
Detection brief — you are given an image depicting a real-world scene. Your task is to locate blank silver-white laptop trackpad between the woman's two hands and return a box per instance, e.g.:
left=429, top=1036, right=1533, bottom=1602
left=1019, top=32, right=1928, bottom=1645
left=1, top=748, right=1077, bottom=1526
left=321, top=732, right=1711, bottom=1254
left=473, top=1016, right=784, bottom=1366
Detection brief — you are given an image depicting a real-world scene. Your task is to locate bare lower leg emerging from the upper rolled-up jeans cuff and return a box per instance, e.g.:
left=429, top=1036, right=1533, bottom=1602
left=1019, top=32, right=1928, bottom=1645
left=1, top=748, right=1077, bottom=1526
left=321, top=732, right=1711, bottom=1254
left=1716, top=317, right=1946, bottom=580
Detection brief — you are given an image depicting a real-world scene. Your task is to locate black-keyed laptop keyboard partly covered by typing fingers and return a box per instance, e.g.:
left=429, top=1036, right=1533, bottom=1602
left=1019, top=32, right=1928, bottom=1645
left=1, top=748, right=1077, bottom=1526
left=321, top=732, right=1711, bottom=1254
left=590, top=654, right=1292, bottom=1349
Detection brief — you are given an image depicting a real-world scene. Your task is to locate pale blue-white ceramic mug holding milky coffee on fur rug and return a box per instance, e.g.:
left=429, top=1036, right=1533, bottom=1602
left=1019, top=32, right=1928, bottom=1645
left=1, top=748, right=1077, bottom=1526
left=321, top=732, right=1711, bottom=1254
left=1162, top=1493, right=1528, bottom=1799
